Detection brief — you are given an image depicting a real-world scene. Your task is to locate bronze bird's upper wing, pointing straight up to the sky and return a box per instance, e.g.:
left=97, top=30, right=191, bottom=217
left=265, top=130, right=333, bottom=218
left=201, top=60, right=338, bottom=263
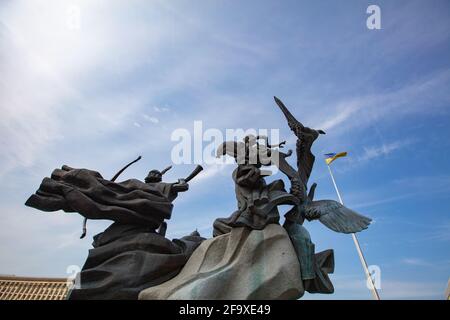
left=274, top=97, right=318, bottom=187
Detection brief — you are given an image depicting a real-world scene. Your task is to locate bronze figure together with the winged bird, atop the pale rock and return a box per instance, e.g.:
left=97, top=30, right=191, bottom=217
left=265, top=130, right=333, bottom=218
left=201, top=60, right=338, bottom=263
left=213, top=98, right=370, bottom=293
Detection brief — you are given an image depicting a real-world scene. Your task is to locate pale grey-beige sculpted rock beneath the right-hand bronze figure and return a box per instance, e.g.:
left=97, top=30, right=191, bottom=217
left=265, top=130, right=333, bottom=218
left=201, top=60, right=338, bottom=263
left=139, top=224, right=304, bottom=300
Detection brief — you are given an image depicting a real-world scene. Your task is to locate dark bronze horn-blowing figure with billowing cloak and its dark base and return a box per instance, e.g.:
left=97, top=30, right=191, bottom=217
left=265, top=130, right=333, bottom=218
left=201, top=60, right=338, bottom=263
left=25, top=158, right=204, bottom=299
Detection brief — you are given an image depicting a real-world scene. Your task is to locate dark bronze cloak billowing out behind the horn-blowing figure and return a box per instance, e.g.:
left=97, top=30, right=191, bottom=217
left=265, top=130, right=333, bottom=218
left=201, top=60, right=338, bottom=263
left=25, top=166, right=176, bottom=229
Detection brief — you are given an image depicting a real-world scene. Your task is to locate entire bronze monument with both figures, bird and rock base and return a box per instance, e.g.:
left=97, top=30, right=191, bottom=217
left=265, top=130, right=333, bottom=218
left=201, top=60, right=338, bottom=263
left=26, top=97, right=371, bottom=299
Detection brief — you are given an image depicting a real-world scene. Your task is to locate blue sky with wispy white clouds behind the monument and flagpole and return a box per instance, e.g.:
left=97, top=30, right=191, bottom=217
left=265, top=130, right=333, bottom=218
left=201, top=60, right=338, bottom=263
left=0, top=0, right=450, bottom=299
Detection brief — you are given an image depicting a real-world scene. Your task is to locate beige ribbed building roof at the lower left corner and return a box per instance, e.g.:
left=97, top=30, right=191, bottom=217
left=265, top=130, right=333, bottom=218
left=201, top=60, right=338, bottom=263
left=0, top=276, right=69, bottom=300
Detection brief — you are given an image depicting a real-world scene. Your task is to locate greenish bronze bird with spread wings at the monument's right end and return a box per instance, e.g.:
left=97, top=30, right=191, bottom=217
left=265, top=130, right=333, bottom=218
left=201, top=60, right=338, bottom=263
left=274, top=97, right=371, bottom=293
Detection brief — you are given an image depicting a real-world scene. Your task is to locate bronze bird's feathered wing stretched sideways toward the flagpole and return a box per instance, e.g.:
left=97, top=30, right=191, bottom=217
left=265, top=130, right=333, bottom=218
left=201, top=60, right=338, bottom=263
left=305, top=200, right=372, bottom=233
